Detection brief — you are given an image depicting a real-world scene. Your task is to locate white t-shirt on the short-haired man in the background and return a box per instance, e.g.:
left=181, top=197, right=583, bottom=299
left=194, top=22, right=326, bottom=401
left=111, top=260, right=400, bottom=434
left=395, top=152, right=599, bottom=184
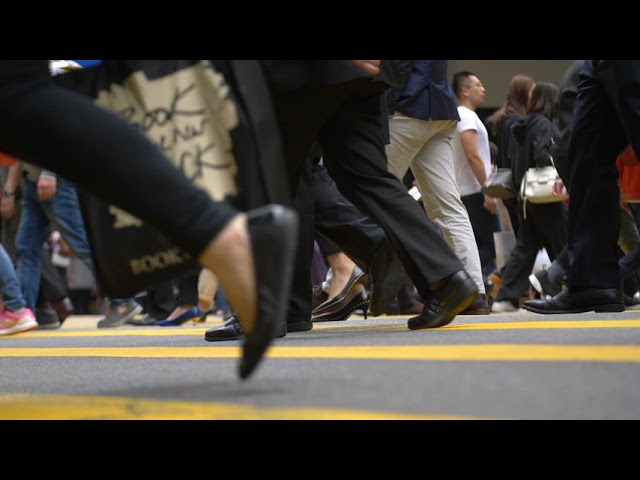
left=453, top=107, right=491, bottom=197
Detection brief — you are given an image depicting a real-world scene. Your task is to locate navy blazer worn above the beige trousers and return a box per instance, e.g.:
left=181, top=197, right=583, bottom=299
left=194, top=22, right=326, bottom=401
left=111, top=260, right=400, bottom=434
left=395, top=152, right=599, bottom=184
left=387, top=60, right=460, bottom=121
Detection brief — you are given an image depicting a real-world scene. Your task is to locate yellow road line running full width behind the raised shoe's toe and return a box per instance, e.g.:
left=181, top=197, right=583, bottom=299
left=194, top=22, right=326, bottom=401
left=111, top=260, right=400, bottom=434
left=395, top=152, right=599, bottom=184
left=0, top=344, right=640, bottom=363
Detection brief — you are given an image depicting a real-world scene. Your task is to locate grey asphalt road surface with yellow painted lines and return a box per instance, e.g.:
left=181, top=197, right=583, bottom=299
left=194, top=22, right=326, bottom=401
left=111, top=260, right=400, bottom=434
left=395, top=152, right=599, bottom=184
left=0, top=310, right=640, bottom=420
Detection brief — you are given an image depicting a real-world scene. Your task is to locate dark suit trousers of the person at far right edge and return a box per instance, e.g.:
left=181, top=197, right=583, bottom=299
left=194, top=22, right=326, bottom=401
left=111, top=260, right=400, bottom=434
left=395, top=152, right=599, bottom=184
left=567, top=60, right=640, bottom=291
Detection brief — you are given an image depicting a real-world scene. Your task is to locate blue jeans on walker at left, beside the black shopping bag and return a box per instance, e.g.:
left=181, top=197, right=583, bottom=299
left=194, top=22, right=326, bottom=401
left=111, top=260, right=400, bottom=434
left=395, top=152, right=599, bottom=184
left=16, top=177, right=93, bottom=311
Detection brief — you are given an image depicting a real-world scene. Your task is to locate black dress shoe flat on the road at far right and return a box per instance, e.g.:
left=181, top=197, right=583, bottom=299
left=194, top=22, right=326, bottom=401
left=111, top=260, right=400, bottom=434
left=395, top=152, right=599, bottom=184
left=522, top=288, right=625, bottom=314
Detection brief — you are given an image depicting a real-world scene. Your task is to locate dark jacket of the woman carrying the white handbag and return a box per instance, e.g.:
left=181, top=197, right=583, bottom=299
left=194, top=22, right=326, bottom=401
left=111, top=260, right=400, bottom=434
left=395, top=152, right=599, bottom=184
left=511, top=113, right=553, bottom=192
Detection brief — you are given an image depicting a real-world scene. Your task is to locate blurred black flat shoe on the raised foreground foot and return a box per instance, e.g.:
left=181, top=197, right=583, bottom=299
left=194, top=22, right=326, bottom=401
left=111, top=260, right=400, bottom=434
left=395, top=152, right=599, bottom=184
left=238, top=205, right=298, bottom=379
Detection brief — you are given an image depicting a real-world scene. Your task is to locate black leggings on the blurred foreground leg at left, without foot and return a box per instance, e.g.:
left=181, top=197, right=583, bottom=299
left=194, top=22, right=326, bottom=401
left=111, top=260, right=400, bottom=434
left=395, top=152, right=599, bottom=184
left=0, top=60, right=237, bottom=258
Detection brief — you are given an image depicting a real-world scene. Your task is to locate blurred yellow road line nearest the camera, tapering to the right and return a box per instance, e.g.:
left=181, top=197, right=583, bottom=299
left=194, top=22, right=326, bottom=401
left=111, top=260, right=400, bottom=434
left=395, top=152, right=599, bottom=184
left=0, top=394, right=481, bottom=420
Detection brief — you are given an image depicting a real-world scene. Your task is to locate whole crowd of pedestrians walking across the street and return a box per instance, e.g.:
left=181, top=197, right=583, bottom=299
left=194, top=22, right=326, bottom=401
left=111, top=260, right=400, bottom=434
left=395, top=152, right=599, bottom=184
left=0, top=60, right=640, bottom=378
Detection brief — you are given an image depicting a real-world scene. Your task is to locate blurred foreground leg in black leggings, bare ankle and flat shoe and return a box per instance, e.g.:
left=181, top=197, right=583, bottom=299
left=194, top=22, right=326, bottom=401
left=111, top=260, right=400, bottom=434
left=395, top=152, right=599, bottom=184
left=0, top=61, right=297, bottom=378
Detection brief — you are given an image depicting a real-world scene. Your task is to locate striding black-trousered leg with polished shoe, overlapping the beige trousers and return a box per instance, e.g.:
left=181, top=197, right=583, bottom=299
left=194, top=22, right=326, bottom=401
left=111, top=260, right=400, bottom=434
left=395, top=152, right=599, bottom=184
left=319, top=82, right=478, bottom=329
